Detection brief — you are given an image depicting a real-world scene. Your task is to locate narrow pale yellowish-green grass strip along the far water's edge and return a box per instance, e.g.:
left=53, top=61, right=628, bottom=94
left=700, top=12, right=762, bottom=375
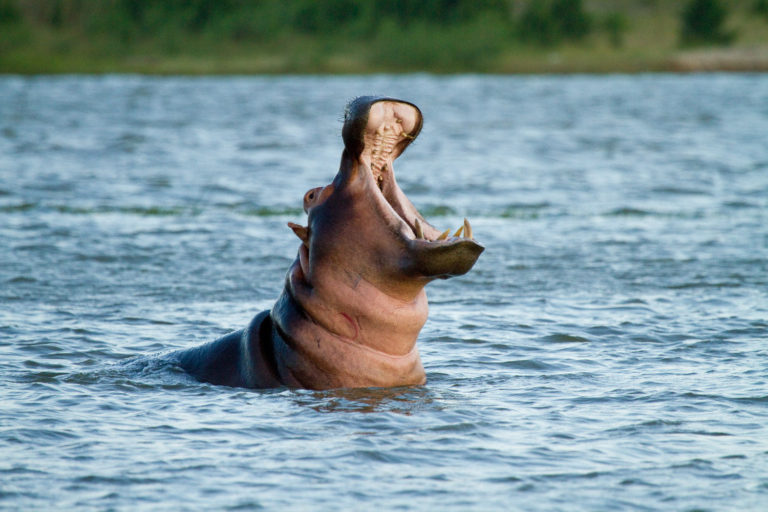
left=0, top=47, right=768, bottom=76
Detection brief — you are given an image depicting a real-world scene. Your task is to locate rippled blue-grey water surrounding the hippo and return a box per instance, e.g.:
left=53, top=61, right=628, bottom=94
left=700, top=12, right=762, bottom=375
left=0, top=75, right=768, bottom=511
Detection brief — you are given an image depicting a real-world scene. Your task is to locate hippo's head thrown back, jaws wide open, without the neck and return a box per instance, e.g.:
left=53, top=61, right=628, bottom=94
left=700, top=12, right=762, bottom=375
left=291, top=96, right=484, bottom=289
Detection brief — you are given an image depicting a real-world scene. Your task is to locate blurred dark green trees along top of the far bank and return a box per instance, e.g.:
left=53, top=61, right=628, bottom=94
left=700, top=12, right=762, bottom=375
left=0, top=0, right=768, bottom=46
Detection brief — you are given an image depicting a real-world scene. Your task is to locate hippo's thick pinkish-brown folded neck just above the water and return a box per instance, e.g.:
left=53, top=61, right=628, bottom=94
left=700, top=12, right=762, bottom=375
left=271, top=259, right=428, bottom=389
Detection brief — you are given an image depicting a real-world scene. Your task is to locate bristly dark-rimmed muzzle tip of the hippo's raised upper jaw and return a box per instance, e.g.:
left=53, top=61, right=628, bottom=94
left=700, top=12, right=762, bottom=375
left=341, top=96, right=423, bottom=159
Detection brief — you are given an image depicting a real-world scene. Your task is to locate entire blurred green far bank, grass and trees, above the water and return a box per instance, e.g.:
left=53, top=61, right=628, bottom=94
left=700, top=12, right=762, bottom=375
left=0, top=0, right=768, bottom=74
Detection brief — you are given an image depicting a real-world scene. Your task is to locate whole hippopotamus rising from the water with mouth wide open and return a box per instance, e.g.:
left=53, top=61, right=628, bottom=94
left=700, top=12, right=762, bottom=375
left=174, top=96, right=484, bottom=390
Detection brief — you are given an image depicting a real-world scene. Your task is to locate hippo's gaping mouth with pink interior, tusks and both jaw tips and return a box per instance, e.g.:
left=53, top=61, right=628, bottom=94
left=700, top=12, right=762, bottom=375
left=343, top=97, right=483, bottom=277
